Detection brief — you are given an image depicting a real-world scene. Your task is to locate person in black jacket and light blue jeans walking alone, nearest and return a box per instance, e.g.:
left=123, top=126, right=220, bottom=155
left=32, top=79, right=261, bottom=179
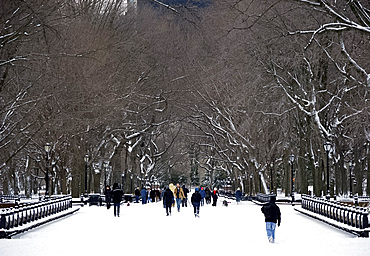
left=261, top=196, right=281, bottom=243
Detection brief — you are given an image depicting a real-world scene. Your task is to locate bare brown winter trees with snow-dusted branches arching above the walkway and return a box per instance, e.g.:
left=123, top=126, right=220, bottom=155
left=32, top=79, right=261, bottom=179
left=0, top=0, right=370, bottom=197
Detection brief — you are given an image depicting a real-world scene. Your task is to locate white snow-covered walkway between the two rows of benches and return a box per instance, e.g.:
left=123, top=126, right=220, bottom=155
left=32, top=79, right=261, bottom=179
left=0, top=195, right=370, bottom=256
